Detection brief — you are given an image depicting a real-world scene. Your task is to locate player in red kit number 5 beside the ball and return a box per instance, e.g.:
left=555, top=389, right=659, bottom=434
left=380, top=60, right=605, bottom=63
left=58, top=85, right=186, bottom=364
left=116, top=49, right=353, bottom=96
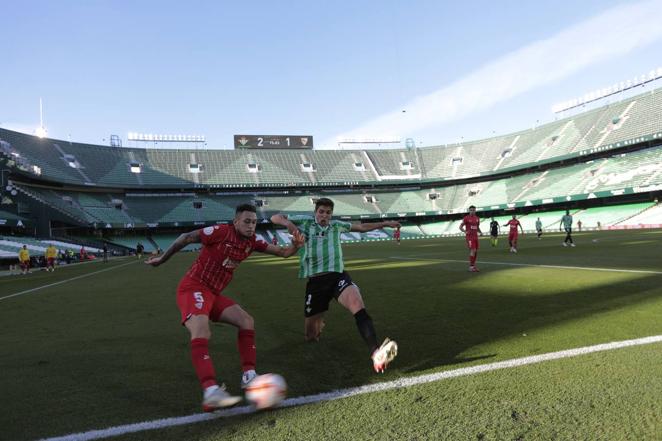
left=145, top=204, right=304, bottom=412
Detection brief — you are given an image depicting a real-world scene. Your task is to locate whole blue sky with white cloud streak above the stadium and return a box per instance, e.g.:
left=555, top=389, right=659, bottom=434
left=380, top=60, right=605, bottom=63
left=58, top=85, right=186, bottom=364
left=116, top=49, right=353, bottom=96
left=0, top=0, right=662, bottom=148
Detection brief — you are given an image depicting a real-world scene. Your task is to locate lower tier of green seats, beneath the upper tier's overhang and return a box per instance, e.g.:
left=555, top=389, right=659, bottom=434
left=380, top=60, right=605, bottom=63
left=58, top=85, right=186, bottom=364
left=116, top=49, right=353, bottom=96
left=6, top=143, right=662, bottom=226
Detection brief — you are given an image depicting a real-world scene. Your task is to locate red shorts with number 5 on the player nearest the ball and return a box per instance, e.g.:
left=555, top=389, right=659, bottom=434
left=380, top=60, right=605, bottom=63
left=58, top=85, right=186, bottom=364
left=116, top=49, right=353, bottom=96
left=177, top=277, right=236, bottom=324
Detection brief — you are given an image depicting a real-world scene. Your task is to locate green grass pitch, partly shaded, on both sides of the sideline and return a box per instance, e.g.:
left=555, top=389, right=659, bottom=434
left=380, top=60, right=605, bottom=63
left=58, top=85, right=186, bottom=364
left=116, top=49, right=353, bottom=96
left=0, top=230, right=662, bottom=440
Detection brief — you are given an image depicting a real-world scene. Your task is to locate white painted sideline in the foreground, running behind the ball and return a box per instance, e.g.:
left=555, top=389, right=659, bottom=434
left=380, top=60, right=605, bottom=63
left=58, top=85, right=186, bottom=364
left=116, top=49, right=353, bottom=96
left=41, top=335, right=662, bottom=441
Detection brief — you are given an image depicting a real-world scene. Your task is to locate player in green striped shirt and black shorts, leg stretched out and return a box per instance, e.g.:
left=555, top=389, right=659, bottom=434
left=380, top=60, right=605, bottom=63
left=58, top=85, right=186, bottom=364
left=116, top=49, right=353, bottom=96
left=271, top=198, right=400, bottom=372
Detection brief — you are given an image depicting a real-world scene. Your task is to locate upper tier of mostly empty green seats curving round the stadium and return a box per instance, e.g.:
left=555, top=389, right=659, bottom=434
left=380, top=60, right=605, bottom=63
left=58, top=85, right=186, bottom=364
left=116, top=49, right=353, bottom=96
left=0, top=89, right=662, bottom=189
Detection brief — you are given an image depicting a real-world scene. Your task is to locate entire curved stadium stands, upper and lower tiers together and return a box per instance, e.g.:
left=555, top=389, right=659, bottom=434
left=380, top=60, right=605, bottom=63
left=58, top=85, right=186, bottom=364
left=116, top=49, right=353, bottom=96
left=0, top=89, right=662, bottom=251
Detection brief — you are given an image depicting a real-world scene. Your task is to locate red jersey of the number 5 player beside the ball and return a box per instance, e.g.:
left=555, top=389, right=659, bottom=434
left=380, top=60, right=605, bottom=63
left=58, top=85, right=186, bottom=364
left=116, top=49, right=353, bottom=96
left=186, top=225, right=268, bottom=293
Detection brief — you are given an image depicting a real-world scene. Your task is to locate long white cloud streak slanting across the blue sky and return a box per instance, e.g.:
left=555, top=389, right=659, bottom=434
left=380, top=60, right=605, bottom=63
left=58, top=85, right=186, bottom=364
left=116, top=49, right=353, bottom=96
left=330, top=0, right=662, bottom=147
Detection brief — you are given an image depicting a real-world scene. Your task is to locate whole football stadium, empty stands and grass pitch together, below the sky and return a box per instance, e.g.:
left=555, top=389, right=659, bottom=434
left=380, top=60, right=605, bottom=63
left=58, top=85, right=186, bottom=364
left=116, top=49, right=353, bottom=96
left=0, top=1, right=662, bottom=440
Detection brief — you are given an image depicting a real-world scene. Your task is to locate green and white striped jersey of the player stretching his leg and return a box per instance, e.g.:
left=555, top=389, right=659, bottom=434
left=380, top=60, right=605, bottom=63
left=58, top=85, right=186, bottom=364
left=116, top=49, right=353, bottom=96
left=289, top=216, right=352, bottom=279
